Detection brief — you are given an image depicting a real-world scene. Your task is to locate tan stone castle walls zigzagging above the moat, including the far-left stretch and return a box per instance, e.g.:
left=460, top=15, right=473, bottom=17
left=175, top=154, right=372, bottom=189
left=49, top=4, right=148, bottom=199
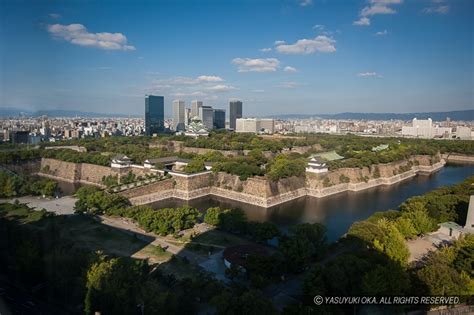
left=40, top=156, right=456, bottom=207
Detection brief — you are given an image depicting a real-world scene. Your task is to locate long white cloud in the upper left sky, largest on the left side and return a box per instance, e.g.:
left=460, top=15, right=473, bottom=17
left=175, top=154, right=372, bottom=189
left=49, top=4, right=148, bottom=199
left=47, top=24, right=135, bottom=51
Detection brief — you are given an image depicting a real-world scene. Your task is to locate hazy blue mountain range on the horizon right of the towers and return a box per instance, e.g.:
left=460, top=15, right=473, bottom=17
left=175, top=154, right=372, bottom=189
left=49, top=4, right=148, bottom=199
left=266, top=110, right=474, bottom=121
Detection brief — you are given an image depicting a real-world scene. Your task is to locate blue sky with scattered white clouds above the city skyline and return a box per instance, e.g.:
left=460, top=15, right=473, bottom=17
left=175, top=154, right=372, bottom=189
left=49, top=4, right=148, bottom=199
left=0, top=0, right=474, bottom=116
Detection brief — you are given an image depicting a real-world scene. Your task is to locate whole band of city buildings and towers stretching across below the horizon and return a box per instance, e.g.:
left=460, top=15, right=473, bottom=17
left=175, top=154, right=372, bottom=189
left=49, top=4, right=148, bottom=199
left=0, top=99, right=474, bottom=144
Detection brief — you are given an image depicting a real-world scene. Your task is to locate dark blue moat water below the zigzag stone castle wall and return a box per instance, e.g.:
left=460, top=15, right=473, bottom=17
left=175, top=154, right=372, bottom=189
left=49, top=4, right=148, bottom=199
left=151, top=164, right=474, bottom=241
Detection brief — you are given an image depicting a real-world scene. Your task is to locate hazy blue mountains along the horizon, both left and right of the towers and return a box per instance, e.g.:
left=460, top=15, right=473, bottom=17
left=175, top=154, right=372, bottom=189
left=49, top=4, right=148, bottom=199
left=0, top=107, right=474, bottom=121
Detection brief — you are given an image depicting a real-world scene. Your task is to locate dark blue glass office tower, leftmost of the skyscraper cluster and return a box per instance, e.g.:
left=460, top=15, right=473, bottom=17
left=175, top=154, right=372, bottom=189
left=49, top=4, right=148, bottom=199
left=145, top=95, right=165, bottom=136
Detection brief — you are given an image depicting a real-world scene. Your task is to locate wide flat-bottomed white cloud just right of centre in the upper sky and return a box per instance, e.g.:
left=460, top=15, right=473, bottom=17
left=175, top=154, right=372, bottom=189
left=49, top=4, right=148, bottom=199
left=276, top=35, right=336, bottom=55
